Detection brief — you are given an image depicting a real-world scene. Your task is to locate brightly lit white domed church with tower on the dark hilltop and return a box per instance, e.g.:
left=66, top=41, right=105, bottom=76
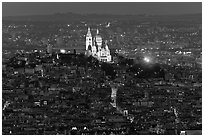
left=85, top=28, right=111, bottom=62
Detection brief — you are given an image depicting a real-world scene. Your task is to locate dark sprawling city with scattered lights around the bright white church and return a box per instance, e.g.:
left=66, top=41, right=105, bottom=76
left=2, top=6, right=202, bottom=135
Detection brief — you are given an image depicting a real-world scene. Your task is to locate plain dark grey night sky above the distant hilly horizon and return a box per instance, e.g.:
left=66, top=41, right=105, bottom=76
left=2, top=2, right=202, bottom=16
